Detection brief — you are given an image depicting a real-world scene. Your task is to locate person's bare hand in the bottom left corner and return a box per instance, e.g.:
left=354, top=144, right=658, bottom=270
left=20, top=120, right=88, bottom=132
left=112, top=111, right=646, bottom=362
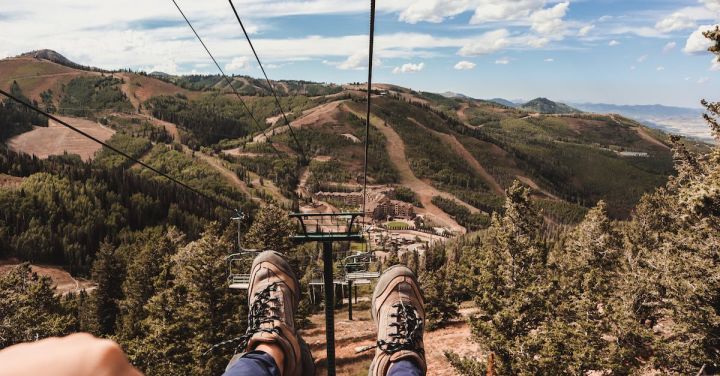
left=0, top=333, right=142, bottom=376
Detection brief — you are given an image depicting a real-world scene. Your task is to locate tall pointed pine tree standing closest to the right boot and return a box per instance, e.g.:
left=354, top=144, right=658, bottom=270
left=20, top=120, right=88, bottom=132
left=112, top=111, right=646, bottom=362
left=470, top=181, right=551, bottom=374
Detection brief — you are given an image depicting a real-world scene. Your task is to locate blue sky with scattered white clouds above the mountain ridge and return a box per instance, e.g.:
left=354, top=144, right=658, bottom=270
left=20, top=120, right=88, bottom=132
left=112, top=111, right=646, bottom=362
left=0, top=0, right=720, bottom=107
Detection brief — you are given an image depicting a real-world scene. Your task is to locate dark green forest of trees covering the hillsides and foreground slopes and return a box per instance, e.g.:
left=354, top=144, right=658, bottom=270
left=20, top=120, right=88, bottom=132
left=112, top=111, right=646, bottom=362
left=0, top=28, right=720, bottom=376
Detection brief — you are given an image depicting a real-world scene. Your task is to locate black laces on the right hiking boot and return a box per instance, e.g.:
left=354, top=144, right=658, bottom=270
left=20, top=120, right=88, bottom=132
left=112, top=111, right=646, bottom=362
left=377, top=301, right=424, bottom=355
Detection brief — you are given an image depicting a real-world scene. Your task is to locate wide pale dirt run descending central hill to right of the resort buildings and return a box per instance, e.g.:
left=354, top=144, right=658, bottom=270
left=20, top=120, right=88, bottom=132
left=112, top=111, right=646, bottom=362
left=347, top=107, right=466, bottom=233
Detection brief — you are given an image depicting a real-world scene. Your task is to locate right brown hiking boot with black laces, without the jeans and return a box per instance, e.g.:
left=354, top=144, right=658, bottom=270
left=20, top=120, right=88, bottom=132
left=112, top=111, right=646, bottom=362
left=368, top=265, right=427, bottom=376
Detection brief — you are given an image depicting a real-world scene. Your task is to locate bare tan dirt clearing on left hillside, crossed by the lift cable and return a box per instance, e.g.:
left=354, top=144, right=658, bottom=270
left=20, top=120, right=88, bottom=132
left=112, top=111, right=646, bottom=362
left=8, top=116, right=115, bottom=161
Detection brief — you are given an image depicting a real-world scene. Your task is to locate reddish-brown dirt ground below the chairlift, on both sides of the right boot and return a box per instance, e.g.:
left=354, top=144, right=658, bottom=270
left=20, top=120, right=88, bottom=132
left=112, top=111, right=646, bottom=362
left=301, top=297, right=484, bottom=376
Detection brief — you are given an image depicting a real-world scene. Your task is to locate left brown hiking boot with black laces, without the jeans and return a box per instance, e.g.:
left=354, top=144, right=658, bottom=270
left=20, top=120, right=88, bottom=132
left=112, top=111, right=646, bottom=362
left=228, top=251, right=315, bottom=376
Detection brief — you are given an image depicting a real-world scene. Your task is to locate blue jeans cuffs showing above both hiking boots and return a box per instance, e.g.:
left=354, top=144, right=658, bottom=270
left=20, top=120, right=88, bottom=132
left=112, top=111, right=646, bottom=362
left=223, top=351, right=423, bottom=376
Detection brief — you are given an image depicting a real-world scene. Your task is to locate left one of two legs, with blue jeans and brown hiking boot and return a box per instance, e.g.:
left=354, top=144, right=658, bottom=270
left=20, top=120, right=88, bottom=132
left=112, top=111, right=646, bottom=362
left=225, top=251, right=315, bottom=376
